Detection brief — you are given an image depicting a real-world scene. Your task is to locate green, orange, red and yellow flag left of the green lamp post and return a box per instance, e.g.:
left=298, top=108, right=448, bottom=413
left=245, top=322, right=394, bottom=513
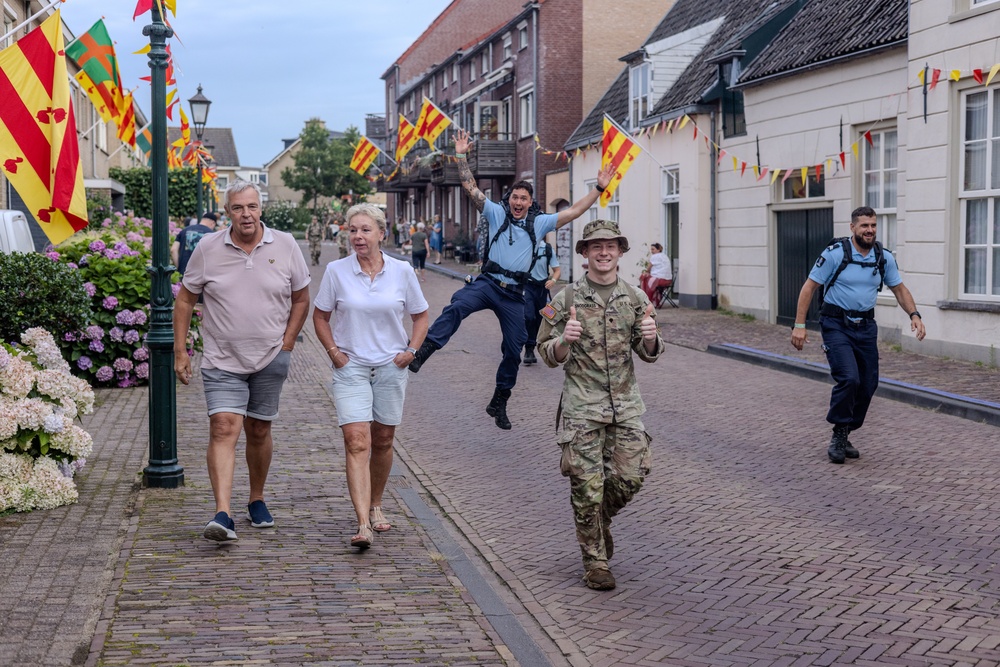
left=66, top=19, right=125, bottom=123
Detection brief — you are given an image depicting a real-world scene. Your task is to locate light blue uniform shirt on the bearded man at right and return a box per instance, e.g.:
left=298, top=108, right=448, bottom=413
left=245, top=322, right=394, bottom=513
left=809, top=243, right=903, bottom=311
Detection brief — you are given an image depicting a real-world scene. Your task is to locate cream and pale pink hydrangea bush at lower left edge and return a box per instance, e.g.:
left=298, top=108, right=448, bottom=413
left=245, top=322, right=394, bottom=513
left=0, top=328, right=94, bottom=514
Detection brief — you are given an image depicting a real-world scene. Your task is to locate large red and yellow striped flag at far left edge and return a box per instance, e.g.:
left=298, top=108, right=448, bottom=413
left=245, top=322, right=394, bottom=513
left=0, top=10, right=87, bottom=244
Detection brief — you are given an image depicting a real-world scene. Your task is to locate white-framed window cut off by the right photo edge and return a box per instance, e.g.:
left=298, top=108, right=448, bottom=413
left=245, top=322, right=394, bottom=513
left=959, top=88, right=1000, bottom=301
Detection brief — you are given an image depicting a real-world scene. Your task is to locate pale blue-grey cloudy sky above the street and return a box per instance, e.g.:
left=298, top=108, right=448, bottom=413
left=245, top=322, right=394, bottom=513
left=60, top=0, right=450, bottom=166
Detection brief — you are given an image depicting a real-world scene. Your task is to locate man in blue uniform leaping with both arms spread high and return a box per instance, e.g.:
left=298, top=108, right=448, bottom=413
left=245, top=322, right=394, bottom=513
left=410, top=130, right=614, bottom=429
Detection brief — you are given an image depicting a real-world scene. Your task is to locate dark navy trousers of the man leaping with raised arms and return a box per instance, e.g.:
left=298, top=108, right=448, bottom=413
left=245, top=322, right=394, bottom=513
left=427, top=276, right=528, bottom=389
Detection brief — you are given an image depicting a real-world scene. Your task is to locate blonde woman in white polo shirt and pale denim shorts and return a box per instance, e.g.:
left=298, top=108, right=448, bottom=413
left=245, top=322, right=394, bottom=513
left=313, top=204, right=430, bottom=549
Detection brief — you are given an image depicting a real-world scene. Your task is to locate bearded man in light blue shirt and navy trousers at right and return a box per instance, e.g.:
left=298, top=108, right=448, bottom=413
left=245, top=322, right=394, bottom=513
left=792, top=206, right=927, bottom=463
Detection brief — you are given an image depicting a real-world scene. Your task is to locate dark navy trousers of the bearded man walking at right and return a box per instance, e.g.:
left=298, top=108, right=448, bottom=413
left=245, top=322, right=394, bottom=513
left=819, top=315, right=878, bottom=431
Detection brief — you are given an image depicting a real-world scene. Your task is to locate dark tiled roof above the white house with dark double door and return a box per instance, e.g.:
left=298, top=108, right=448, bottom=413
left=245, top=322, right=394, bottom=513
left=740, top=0, right=909, bottom=84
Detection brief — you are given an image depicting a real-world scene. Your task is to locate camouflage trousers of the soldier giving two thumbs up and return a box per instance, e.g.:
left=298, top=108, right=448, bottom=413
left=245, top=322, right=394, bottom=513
left=559, top=417, right=653, bottom=570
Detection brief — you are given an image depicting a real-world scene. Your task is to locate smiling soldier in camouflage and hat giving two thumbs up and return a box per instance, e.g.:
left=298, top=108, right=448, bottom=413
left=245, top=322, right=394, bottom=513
left=538, top=220, right=664, bottom=590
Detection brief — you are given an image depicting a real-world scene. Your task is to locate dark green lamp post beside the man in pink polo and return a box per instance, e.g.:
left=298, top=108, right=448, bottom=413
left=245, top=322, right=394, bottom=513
left=142, top=2, right=184, bottom=489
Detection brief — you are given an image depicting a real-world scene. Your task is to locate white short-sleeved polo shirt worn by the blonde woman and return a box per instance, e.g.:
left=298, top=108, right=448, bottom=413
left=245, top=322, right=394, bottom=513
left=313, top=253, right=428, bottom=367
